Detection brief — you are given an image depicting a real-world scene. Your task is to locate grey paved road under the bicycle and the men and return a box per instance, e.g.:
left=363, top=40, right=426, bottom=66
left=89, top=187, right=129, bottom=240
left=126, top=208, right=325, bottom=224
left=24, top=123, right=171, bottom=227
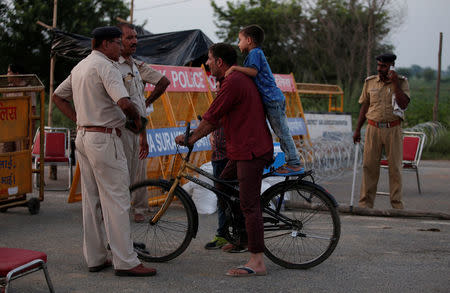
left=0, top=161, right=450, bottom=293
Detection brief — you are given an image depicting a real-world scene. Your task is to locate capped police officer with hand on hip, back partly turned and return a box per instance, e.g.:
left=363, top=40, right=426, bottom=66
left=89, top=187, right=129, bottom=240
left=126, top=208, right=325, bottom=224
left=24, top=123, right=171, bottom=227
left=52, top=27, right=156, bottom=276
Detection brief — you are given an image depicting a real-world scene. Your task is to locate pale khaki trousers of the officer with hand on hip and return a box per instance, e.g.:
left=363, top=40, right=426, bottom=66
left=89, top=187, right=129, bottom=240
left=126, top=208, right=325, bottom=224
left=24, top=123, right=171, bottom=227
left=75, top=130, right=140, bottom=270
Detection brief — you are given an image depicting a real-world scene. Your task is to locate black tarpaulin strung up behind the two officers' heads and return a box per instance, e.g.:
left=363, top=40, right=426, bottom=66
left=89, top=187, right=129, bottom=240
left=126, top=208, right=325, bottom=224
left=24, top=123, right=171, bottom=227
left=52, top=29, right=213, bottom=66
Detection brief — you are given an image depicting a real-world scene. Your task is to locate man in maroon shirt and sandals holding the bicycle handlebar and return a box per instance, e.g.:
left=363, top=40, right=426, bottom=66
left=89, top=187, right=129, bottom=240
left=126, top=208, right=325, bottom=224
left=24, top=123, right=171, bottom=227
left=175, top=43, right=273, bottom=277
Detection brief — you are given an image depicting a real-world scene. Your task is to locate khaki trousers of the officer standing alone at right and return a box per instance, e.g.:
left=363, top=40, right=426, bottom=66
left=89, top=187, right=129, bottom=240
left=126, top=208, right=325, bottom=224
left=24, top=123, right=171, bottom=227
left=359, top=125, right=403, bottom=209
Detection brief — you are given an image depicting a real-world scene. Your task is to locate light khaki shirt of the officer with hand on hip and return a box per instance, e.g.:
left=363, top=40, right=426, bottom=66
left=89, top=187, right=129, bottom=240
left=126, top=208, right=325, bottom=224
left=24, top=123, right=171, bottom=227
left=55, top=50, right=128, bottom=128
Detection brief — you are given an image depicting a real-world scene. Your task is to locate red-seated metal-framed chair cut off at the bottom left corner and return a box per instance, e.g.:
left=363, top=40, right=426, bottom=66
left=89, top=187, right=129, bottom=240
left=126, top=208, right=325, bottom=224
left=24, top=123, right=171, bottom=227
left=0, top=247, right=55, bottom=293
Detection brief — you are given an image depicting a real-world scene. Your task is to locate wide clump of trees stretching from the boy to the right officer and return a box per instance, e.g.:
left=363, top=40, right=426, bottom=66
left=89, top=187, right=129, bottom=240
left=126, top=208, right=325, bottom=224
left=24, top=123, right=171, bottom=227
left=211, top=0, right=393, bottom=110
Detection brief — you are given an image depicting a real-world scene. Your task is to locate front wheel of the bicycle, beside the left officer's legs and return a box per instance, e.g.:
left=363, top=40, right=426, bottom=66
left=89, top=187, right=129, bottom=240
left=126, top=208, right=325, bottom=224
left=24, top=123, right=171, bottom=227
left=130, top=180, right=198, bottom=262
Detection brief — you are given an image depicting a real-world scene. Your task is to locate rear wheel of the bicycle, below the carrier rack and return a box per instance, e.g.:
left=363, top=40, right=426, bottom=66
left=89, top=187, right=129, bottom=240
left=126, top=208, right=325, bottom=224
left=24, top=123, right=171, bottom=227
left=261, top=180, right=341, bottom=269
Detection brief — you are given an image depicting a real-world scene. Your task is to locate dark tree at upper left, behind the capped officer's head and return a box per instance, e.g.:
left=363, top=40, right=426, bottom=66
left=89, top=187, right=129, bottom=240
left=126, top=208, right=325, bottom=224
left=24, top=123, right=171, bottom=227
left=0, top=0, right=129, bottom=86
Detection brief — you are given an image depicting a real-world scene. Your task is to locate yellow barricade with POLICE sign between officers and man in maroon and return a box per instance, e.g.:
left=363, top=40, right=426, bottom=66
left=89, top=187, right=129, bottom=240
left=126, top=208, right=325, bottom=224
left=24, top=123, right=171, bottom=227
left=145, top=65, right=212, bottom=178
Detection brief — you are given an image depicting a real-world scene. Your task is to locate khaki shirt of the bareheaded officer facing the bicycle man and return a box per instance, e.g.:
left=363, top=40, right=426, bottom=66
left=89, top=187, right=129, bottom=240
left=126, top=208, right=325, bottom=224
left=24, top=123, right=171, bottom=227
left=118, top=56, right=163, bottom=116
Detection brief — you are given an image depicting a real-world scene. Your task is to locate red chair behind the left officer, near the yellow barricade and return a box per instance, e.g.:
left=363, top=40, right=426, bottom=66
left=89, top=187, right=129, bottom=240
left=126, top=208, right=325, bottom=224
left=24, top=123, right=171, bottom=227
left=32, top=127, right=73, bottom=190
